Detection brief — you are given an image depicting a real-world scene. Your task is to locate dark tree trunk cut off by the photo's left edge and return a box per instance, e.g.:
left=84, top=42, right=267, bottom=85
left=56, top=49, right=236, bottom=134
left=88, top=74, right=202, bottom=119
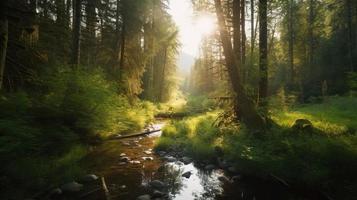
left=0, top=10, right=8, bottom=90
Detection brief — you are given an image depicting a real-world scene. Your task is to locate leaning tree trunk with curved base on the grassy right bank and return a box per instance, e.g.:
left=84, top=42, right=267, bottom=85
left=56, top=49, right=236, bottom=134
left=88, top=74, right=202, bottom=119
left=214, top=0, right=265, bottom=130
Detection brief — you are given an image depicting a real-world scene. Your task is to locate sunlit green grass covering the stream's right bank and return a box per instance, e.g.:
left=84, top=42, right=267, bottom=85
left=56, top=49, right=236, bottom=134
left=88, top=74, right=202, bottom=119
left=156, top=97, right=357, bottom=199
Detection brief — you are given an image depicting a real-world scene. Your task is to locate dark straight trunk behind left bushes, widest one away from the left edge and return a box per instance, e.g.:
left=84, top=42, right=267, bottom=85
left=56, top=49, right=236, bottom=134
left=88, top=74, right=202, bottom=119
left=72, top=0, right=82, bottom=66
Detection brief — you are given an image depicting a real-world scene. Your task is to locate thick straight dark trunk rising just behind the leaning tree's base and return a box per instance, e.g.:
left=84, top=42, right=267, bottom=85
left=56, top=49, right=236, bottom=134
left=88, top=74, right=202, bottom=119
left=259, top=0, right=268, bottom=110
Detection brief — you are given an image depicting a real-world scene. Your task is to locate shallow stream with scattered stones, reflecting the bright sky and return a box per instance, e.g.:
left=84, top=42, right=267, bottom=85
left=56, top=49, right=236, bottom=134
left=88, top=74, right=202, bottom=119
left=80, top=122, right=326, bottom=200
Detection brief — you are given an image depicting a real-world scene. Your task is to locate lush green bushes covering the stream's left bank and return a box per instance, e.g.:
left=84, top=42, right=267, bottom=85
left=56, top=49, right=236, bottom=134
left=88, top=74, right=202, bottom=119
left=0, top=66, right=154, bottom=198
